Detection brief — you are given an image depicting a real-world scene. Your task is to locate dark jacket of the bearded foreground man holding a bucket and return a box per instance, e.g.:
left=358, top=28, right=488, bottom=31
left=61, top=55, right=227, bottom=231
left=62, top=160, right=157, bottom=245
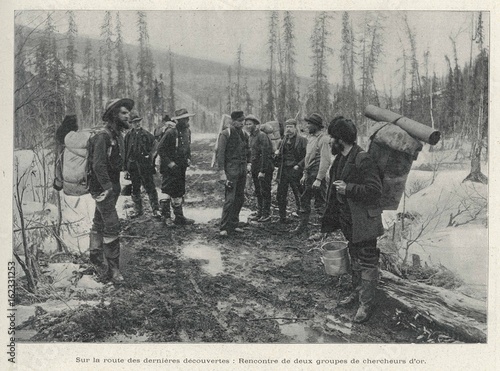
left=321, top=144, right=384, bottom=243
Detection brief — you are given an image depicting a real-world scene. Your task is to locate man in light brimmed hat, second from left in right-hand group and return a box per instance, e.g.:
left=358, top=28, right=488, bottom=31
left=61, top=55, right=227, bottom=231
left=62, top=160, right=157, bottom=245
left=245, top=115, right=274, bottom=222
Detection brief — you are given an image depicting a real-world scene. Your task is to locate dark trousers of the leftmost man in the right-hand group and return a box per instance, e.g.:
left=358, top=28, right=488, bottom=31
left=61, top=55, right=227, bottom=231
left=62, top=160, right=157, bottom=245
left=220, top=163, right=246, bottom=231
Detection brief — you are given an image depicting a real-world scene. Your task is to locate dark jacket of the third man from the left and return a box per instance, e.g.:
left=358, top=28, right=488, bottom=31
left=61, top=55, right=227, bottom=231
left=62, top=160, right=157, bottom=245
left=158, top=126, right=191, bottom=173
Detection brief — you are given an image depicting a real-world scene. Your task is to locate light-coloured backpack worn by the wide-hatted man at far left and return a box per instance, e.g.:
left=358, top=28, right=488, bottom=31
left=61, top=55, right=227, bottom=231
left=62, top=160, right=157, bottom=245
left=61, top=128, right=111, bottom=196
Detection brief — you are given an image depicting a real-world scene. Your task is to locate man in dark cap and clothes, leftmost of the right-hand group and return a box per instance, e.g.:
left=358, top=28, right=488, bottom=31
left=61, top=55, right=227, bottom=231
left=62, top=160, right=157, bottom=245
left=217, top=111, right=250, bottom=236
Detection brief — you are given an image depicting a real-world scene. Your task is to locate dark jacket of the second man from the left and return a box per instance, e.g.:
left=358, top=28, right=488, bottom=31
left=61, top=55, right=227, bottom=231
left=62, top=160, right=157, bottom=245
left=124, top=127, right=155, bottom=173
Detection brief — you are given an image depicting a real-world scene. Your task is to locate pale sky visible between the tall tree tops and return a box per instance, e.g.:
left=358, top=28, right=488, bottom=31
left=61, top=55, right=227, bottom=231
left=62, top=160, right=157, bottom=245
left=15, top=10, right=489, bottom=88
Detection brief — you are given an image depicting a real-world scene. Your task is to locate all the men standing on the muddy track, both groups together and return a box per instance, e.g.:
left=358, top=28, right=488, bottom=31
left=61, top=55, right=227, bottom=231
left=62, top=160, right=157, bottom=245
left=89, top=99, right=383, bottom=322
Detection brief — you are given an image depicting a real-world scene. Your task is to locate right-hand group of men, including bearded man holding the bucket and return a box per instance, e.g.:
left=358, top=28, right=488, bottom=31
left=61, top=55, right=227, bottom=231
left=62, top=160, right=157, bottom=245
left=217, top=111, right=384, bottom=323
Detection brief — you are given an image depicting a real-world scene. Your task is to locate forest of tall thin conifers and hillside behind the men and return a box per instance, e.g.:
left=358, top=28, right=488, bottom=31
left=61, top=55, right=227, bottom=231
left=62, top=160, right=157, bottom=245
left=14, top=11, right=489, bottom=176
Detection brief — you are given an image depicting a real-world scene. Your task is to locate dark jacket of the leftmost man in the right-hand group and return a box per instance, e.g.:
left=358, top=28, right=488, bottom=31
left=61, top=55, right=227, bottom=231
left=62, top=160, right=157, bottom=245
left=217, top=126, right=250, bottom=170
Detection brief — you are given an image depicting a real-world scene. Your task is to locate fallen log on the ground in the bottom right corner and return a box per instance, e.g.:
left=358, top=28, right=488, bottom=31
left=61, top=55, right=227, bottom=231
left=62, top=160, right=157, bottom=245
left=380, top=271, right=487, bottom=343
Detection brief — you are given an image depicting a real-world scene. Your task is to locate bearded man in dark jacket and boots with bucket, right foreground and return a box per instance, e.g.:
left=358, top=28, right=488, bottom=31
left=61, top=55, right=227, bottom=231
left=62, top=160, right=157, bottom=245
left=321, top=116, right=384, bottom=323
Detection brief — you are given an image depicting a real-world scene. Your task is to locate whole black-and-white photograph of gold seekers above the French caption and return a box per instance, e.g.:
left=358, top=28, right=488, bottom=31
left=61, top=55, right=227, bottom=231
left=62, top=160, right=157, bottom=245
left=10, top=9, right=491, bottom=348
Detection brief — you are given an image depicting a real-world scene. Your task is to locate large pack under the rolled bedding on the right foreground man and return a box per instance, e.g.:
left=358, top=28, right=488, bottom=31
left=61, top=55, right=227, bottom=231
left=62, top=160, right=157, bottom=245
left=364, top=123, right=422, bottom=210
